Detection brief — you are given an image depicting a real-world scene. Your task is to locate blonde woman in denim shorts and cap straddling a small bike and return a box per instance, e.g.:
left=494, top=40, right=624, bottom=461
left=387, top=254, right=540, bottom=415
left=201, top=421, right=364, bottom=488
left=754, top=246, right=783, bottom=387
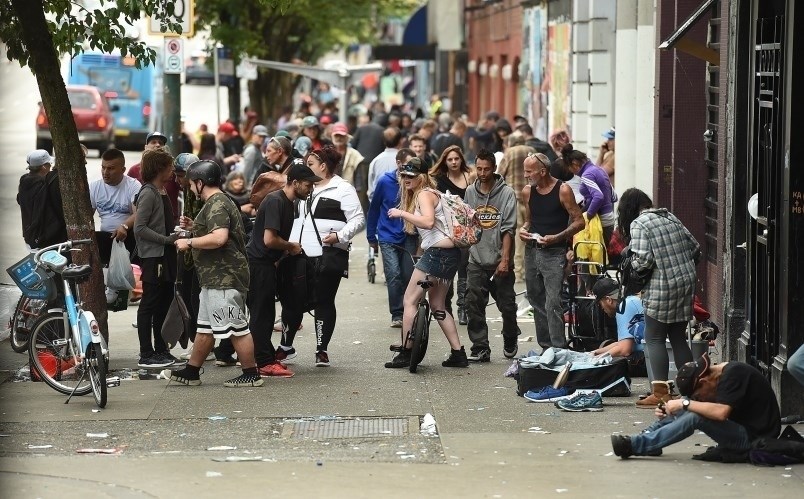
left=385, top=158, right=469, bottom=368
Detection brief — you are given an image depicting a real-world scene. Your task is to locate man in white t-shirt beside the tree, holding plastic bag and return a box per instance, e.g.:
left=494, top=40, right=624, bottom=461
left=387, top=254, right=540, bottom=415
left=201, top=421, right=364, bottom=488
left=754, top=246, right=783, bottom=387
left=89, top=149, right=141, bottom=264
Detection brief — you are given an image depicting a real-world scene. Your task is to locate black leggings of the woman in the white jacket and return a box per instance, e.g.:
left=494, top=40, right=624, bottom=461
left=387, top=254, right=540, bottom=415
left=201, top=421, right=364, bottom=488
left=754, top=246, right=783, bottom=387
left=281, top=271, right=343, bottom=351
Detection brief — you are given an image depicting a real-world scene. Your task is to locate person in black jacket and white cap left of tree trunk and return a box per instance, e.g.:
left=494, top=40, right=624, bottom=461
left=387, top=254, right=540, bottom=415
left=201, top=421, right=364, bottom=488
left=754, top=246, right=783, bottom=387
left=17, top=149, right=67, bottom=249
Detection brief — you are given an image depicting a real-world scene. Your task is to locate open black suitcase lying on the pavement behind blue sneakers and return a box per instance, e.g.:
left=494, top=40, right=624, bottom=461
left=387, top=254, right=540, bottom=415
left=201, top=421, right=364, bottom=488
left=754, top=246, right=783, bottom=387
left=516, top=357, right=631, bottom=397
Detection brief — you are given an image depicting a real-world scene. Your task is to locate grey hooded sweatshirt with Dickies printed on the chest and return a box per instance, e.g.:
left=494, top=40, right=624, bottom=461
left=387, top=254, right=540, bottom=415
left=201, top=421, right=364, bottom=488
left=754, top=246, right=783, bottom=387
left=464, top=173, right=516, bottom=268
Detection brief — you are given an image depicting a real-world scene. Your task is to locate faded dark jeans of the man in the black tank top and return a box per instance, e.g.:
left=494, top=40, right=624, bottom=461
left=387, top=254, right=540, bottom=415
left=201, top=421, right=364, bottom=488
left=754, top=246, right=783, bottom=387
left=525, top=244, right=567, bottom=349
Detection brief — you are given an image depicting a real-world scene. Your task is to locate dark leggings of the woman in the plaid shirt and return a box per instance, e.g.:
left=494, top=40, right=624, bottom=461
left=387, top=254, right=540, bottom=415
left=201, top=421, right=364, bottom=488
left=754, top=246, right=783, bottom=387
left=645, top=315, right=692, bottom=381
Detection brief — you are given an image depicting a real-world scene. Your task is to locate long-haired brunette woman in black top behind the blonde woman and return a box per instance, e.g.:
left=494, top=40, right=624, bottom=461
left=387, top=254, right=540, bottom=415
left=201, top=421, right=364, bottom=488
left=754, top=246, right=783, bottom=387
left=430, top=145, right=475, bottom=325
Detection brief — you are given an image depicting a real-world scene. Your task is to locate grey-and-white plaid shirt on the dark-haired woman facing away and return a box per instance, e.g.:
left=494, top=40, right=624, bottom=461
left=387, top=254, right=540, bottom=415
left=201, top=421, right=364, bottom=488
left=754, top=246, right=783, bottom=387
left=631, top=208, right=700, bottom=323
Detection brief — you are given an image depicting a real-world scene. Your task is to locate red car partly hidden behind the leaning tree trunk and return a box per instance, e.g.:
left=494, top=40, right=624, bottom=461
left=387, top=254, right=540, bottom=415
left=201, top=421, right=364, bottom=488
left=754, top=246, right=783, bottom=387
left=36, top=85, right=117, bottom=155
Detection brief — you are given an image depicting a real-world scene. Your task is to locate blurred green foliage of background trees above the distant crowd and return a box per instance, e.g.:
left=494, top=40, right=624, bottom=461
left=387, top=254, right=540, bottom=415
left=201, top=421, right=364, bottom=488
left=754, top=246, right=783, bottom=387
left=196, top=0, right=414, bottom=122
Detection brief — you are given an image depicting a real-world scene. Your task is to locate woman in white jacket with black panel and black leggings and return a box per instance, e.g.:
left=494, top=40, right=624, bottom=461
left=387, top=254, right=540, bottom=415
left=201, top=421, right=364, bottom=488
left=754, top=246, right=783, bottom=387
left=276, top=145, right=366, bottom=367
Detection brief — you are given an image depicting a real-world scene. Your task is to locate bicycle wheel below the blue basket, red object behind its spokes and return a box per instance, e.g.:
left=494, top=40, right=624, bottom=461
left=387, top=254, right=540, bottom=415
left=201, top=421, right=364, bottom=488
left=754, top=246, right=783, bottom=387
left=28, top=312, right=92, bottom=395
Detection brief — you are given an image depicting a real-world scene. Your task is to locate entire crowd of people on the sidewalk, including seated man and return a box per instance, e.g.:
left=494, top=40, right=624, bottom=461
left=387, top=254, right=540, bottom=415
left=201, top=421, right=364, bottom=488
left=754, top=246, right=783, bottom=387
left=18, top=102, right=804, bottom=457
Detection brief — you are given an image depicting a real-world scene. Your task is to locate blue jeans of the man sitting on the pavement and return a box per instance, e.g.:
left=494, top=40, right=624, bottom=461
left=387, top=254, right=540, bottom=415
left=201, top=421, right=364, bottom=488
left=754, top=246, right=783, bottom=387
left=631, top=411, right=751, bottom=456
